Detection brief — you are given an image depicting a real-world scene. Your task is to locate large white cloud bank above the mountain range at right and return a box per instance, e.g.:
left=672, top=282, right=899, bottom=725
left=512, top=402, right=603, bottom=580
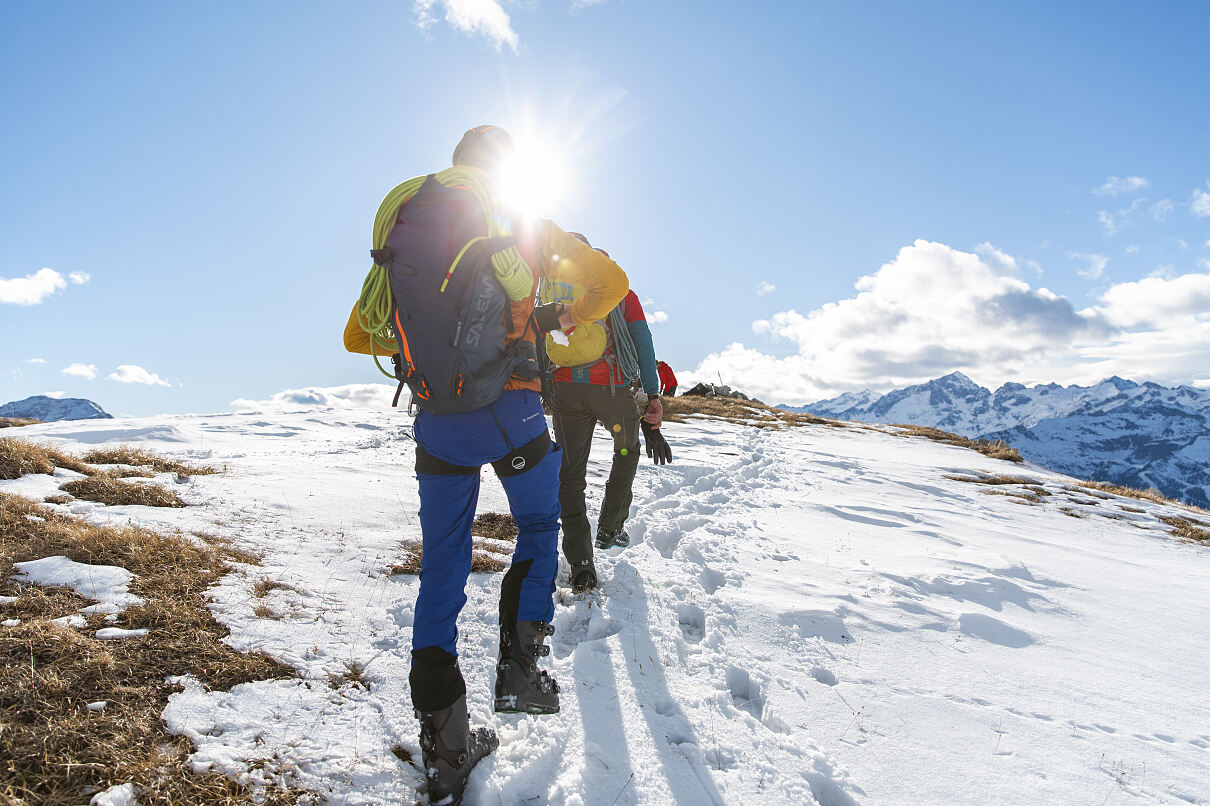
left=686, top=241, right=1210, bottom=403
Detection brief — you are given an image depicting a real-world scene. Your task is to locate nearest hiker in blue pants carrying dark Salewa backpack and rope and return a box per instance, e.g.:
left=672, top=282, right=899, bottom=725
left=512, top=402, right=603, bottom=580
left=345, top=126, right=629, bottom=806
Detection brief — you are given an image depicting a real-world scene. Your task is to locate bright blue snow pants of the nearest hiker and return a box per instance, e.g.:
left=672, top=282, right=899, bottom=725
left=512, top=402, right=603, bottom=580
left=411, top=390, right=561, bottom=656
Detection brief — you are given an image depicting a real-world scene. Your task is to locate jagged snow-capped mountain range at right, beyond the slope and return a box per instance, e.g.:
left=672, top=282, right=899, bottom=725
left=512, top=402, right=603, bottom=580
left=787, top=373, right=1210, bottom=507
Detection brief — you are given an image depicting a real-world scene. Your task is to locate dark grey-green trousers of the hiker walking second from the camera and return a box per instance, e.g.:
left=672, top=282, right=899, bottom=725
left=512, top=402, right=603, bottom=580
left=551, top=382, right=639, bottom=563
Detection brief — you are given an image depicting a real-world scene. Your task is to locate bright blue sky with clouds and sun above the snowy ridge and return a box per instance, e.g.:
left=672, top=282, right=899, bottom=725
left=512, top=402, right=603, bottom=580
left=0, top=0, right=1210, bottom=414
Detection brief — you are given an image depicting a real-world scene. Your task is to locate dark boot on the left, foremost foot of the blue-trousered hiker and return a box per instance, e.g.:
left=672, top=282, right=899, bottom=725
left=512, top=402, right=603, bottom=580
left=415, top=695, right=500, bottom=806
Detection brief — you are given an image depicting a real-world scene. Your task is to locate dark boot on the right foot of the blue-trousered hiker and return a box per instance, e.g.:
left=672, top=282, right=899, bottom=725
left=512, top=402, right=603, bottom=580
left=496, top=621, right=559, bottom=714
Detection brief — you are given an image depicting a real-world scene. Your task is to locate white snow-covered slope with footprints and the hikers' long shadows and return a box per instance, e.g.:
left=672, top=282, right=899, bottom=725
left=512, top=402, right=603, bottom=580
left=0, top=410, right=1210, bottom=806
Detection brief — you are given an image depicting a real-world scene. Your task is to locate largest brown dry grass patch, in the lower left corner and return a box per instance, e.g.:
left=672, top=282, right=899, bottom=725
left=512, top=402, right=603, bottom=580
left=0, top=494, right=298, bottom=806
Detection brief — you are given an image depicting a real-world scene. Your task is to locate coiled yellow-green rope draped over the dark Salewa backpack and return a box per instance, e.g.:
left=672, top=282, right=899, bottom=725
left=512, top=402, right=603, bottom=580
left=357, top=166, right=534, bottom=378
